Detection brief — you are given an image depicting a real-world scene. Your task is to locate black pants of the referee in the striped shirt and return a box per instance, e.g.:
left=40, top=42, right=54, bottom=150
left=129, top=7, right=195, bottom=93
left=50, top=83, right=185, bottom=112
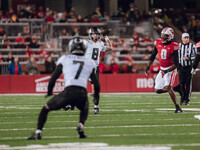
left=178, top=66, right=192, bottom=102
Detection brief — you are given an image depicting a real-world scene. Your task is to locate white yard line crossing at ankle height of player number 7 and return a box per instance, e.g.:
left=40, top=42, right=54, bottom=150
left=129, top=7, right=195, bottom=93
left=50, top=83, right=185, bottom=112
left=0, top=124, right=200, bottom=131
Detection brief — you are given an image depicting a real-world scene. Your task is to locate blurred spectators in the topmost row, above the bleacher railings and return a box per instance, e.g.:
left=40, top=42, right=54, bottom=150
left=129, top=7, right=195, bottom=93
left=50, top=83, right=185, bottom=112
left=0, top=3, right=150, bottom=23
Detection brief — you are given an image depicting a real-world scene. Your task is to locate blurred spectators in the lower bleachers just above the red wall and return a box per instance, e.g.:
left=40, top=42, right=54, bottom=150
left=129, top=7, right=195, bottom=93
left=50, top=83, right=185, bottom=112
left=0, top=29, right=157, bottom=74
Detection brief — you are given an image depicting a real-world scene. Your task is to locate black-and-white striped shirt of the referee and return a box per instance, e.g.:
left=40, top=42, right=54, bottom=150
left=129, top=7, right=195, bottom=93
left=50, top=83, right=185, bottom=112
left=178, top=43, right=197, bottom=67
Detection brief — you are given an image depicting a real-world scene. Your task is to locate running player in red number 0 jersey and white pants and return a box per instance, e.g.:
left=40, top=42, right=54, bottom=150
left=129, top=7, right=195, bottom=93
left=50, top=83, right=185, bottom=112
left=145, top=27, right=183, bottom=113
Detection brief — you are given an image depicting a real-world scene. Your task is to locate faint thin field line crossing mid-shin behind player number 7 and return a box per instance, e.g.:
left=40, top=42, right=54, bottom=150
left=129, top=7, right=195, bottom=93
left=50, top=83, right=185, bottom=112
left=0, top=118, right=193, bottom=125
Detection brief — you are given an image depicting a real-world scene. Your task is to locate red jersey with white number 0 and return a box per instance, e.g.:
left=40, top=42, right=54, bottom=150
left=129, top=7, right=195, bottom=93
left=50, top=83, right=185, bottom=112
left=154, top=39, right=180, bottom=67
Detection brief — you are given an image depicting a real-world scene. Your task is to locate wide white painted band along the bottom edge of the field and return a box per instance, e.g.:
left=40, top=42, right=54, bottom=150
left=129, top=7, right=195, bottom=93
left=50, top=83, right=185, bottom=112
left=0, top=143, right=171, bottom=150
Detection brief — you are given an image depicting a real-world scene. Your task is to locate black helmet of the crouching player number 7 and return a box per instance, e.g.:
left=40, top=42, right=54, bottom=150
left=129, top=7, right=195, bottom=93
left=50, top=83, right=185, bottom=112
left=68, top=37, right=86, bottom=55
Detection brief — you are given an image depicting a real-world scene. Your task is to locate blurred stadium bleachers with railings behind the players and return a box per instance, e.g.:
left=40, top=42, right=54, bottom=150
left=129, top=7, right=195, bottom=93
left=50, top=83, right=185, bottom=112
left=0, top=5, right=198, bottom=77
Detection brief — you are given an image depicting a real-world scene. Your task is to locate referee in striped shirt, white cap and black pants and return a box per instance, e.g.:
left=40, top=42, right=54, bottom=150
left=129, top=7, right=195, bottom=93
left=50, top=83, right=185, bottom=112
left=174, top=33, right=197, bottom=105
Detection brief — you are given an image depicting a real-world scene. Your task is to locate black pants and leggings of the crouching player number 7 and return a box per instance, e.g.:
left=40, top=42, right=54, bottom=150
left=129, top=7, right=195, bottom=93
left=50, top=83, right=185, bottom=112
left=37, top=86, right=89, bottom=130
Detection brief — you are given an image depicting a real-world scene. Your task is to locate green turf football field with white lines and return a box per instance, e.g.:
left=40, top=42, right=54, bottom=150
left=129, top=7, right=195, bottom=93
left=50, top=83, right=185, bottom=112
left=0, top=94, right=200, bottom=150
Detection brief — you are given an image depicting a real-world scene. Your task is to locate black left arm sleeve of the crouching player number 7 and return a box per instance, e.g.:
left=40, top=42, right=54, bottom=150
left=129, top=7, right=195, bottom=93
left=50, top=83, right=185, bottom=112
left=47, top=64, right=62, bottom=95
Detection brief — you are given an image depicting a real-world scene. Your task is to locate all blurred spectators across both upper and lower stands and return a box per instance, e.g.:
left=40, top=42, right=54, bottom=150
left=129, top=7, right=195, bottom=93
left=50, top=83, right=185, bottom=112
left=0, top=3, right=159, bottom=75
